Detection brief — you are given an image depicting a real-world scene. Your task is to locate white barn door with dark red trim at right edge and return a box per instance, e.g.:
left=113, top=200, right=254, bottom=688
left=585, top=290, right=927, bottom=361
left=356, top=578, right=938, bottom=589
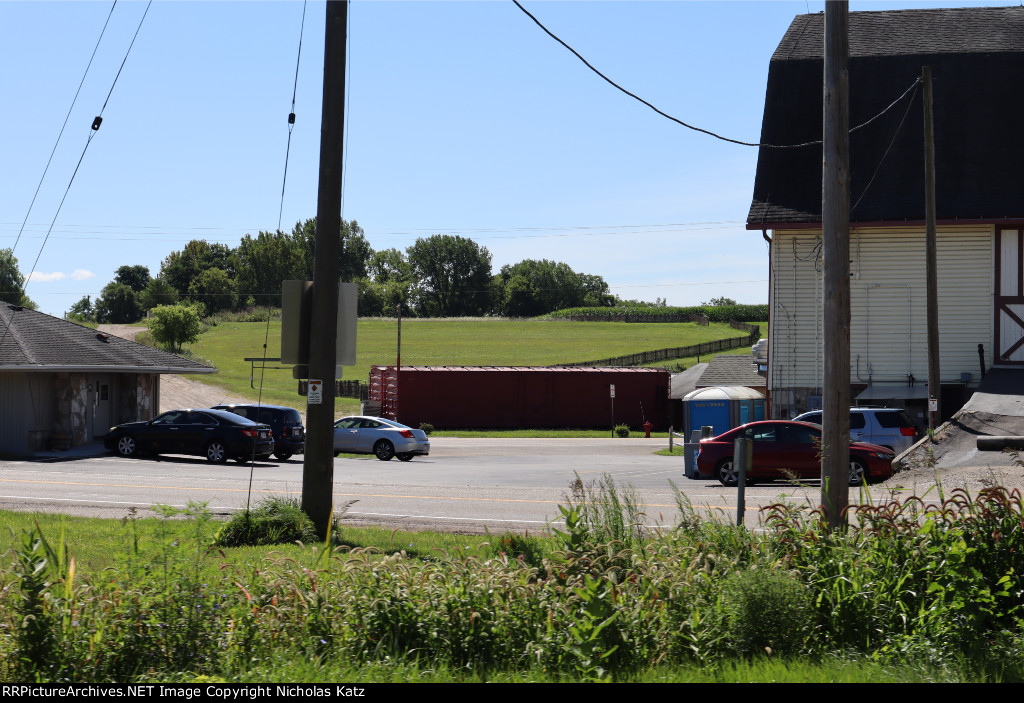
left=992, top=229, right=1024, bottom=366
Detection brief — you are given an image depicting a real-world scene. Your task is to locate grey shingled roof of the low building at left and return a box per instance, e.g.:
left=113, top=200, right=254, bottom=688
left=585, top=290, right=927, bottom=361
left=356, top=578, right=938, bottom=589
left=0, top=303, right=217, bottom=374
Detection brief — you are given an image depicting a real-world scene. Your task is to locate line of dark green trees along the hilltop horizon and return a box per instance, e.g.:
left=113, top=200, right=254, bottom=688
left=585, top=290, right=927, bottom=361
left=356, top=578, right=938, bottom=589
left=48, top=218, right=626, bottom=323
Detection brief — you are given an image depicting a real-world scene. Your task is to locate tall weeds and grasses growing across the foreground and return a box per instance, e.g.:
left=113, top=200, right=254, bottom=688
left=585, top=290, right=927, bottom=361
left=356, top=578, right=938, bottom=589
left=6, top=477, right=1024, bottom=682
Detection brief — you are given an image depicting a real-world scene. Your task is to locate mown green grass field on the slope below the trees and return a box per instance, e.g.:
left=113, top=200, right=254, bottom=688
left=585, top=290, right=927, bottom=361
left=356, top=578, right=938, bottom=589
left=191, top=318, right=761, bottom=415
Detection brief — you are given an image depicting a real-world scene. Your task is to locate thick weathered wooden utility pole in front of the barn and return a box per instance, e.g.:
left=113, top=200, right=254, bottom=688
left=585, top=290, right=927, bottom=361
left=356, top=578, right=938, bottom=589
left=821, top=0, right=850, bottom=529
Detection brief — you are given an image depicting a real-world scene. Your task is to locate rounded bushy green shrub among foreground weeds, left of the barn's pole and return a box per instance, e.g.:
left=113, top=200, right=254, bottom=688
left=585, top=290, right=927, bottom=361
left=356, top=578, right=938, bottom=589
left=722, top=568, right=813, bottom=655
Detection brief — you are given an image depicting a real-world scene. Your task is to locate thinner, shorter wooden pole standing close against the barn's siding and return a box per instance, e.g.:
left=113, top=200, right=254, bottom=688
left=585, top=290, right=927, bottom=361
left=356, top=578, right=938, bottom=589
left=921, top=65, right=942, bottom=430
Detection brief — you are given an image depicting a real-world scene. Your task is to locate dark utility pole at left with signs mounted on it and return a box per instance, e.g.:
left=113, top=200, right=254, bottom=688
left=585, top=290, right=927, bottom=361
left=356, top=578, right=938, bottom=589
left=302, top=0, right=348, bottom=537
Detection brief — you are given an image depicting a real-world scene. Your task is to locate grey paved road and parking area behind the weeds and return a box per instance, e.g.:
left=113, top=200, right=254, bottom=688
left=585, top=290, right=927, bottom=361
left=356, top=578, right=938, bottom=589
left=0, top=438, right=888, bottom=532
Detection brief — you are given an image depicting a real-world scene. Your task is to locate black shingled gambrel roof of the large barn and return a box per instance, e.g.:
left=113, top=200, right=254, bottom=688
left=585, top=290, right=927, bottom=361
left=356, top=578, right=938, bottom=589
left=746, top=7, right=1024, bottom=228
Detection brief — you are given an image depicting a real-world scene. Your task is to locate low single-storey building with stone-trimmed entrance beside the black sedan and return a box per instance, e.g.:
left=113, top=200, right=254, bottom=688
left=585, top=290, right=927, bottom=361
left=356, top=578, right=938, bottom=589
left=0, top=303, right=217, bottom=453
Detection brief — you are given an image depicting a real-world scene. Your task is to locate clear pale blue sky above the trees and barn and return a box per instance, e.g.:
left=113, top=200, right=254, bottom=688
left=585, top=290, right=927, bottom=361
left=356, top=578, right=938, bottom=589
left=0, top=0, right=1016, bottom=315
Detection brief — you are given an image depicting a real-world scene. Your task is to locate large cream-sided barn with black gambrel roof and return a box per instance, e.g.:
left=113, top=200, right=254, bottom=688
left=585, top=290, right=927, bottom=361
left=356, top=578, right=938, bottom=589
left=746, top=7, right=1024, bottom=424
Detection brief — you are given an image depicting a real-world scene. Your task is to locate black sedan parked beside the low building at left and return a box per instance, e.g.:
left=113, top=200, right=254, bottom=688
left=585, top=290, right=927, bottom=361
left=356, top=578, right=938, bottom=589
left=103, top=409, right=273, bottom=464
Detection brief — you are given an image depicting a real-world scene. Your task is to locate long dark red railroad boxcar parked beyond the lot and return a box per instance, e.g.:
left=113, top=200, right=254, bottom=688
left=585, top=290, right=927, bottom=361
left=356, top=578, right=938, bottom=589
left=370, top=366, right=670, bottom=432
